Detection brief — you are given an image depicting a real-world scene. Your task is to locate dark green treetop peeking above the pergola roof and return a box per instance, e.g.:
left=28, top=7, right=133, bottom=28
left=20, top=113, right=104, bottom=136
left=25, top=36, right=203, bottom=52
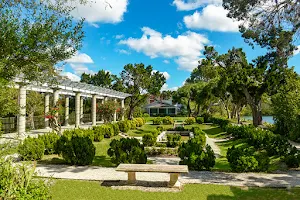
left=80, top=69, right=117, bottom=88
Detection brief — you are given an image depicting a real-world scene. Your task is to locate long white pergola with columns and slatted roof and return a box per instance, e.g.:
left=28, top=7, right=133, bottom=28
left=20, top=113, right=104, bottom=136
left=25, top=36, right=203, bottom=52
left=14, top=78, right=130, bottom=135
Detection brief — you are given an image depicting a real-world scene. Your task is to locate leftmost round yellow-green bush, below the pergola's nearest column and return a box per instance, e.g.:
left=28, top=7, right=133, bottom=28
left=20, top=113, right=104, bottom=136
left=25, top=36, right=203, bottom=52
left=18, top=137, right=45, bottom=160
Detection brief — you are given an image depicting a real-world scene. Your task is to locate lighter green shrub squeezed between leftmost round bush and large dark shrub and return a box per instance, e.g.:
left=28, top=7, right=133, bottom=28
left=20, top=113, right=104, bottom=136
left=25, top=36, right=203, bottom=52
left=38, top=133, right=59, bottom=155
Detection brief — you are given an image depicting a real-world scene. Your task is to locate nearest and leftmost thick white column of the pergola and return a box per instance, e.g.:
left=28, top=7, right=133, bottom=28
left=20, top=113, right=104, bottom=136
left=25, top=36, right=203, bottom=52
left=18, top=85, right=26, bottom=137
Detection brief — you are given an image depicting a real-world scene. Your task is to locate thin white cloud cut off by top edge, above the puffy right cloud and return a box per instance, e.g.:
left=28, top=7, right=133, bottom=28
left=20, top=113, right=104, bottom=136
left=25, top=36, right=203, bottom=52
left=173, top=0, right=222, bottom=11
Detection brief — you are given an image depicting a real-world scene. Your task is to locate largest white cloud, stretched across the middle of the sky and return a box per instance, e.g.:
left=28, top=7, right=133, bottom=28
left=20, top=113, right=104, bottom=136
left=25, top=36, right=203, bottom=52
left=119, top=27, right=209, bottom=71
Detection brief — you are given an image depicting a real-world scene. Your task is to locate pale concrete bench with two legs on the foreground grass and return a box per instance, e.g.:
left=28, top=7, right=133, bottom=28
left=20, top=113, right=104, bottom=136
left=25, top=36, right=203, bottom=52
left=116, top=164, right=189, bottom=187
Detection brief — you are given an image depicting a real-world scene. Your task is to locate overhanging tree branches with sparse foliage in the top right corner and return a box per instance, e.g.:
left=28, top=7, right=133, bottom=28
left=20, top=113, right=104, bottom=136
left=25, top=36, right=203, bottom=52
left=223, top=0, right=300, bottom=46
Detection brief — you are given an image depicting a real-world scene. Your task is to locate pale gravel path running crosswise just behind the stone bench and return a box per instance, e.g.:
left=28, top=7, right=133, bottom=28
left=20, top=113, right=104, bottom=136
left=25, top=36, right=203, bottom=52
left=36, top=165, right=300, bottom=187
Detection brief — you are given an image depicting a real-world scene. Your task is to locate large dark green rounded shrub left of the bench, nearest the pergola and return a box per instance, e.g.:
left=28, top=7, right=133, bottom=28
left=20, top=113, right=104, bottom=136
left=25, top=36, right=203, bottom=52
left=58, top=131, right=96, bottom=165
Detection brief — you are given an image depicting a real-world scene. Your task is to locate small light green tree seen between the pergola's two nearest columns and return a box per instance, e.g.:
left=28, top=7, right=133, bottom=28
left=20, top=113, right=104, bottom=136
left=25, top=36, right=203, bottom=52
left=26, top=91, right=44, bottom=129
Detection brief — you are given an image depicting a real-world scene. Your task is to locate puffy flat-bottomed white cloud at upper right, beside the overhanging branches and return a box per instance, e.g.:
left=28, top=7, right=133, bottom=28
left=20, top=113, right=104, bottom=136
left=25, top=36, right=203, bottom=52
left=183, top=5, right=241, bottom=32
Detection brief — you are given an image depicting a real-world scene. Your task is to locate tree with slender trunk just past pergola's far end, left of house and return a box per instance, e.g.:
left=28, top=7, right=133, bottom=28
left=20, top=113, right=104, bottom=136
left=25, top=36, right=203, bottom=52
left=121, top=63, right=166, bottom=119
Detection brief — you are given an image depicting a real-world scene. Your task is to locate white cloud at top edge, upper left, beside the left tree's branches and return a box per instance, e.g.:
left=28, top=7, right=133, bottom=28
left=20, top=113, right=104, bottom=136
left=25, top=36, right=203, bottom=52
left=72, top=0, right=128, bottom=24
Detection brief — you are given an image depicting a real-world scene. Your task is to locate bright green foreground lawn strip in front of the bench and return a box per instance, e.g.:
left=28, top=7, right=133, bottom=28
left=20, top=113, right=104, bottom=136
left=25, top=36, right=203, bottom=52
left=51, top=180, right=300, bottom=200
